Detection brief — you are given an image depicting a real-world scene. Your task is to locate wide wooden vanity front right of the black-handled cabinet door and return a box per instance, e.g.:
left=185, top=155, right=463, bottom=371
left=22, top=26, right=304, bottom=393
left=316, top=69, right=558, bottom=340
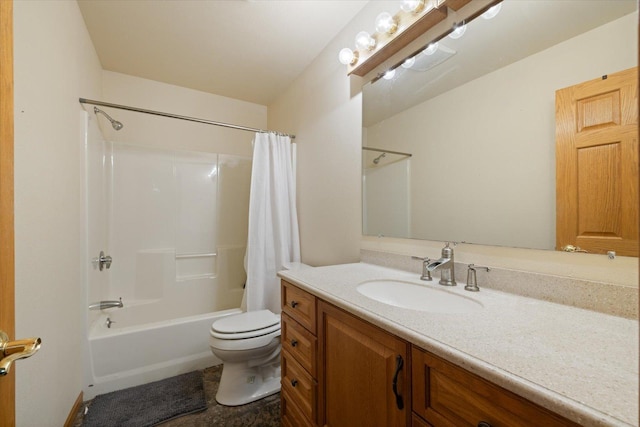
left=412, top=347, right=578, bottom=427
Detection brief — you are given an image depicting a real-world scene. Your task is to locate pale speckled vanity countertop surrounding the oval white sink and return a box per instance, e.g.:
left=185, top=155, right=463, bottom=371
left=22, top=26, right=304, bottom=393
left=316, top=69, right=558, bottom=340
left=279, top=263, right=639, bottom=426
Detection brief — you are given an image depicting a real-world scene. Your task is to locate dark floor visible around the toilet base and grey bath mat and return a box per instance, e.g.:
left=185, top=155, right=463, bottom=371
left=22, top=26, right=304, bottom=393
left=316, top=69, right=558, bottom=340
left=73, top=365, right=280, bottom=427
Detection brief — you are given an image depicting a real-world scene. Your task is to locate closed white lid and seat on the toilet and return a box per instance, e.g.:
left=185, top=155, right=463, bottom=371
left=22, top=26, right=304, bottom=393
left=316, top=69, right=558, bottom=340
left=211, top=310, right=280, bottom=340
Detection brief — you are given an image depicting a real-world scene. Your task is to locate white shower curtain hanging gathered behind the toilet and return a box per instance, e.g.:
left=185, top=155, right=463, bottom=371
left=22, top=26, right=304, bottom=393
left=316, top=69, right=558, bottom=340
left=245, top=133, right=300, bottom=313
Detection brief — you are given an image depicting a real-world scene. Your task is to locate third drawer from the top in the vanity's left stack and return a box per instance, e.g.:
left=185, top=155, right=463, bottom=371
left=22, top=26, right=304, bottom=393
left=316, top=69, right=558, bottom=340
left=281, top=350, right=318, bottom=422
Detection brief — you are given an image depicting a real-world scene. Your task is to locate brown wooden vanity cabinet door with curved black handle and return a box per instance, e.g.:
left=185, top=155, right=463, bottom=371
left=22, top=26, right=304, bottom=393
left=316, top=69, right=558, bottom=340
left=318, top=302, right=411, bottom=427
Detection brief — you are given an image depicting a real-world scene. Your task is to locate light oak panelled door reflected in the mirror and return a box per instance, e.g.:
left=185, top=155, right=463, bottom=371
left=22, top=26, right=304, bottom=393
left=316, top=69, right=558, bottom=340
left=556, top=67, right=638, bottom=256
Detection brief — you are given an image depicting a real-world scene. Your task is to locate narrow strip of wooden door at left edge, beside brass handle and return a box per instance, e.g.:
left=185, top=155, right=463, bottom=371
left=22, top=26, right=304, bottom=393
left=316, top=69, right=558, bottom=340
left=0, top=0, right=15, bottom=427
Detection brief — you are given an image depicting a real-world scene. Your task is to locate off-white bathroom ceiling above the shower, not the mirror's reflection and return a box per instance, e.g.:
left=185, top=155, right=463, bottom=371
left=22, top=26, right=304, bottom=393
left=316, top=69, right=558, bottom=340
left=78, top=0, right=368, bottom=105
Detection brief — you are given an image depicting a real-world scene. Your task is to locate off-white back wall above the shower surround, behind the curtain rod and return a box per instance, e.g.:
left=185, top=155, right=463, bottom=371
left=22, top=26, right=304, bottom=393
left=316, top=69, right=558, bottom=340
left=100, top=71, right=267, bottom=156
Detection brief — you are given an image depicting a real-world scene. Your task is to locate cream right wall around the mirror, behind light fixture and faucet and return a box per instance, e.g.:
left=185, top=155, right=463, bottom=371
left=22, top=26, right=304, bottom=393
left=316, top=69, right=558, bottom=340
left=269, top=2, right=638, bottom=286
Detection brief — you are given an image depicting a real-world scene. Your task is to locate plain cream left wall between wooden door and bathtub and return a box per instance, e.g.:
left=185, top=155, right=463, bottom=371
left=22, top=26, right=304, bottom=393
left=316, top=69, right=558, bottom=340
left=14, top=1, right=101, bottom=427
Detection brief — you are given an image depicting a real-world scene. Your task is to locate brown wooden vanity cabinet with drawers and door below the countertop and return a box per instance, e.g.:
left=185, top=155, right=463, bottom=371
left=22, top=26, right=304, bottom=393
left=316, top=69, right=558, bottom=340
left=281, top=280, right=578, bottom=427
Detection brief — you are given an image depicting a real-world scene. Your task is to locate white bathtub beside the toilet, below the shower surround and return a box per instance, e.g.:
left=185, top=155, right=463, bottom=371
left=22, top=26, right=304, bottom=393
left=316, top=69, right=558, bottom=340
left=83, top=306, right=241, bottom=400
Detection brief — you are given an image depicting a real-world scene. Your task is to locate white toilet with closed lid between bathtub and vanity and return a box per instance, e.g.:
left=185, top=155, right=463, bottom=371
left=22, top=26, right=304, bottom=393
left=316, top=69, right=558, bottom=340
left=209, top=310, right=280, bottom=406
